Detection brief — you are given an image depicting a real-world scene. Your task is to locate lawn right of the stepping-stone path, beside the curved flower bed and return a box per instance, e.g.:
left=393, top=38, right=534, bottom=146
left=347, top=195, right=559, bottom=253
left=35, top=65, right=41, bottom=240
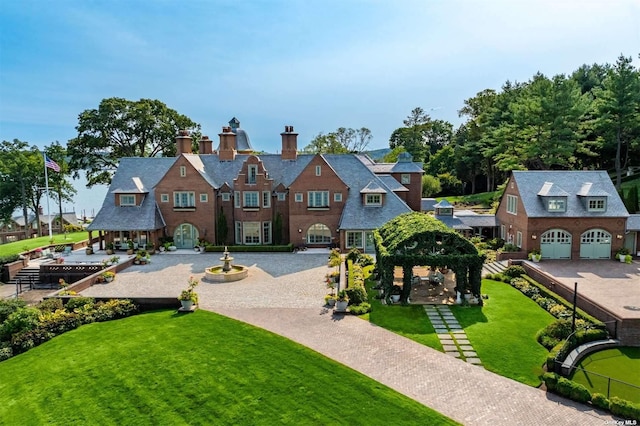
left=451, top=280, right=554, bottom=386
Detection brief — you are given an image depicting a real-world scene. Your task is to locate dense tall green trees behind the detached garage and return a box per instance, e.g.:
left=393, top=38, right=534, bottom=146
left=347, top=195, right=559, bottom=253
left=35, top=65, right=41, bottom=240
left=389, top=55, right=640, bottom=193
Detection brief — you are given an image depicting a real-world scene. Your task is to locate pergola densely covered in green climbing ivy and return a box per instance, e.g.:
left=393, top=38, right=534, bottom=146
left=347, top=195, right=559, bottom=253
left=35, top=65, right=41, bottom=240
left=373, top=212, right=485, bottom=304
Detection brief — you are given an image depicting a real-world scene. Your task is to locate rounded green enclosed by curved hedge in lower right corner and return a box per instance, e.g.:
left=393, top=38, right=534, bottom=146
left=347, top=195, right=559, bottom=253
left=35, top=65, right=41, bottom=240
left=571, top=347, right=640, bottom=403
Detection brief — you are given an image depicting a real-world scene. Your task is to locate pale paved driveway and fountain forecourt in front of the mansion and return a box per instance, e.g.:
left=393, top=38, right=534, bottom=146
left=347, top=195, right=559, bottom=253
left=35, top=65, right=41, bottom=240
left=6, top=252, right=612, bottom=426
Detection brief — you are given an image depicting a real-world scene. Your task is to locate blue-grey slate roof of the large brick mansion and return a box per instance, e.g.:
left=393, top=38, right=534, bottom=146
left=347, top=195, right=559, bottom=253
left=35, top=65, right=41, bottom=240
left=87, top=154, right=411, bottom=231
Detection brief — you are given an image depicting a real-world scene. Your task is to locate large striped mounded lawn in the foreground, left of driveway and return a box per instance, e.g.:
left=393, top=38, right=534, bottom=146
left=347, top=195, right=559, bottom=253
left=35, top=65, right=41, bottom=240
left=0, top=311, right=455, bottom=425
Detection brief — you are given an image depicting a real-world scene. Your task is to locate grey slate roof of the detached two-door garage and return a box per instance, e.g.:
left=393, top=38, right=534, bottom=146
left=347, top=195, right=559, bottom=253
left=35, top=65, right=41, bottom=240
left=510, top=170, right=629, bottom=218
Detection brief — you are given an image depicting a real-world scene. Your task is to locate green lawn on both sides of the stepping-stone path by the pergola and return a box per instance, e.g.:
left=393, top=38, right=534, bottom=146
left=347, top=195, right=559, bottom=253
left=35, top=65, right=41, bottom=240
left=364, top=280, right=554, bottom=386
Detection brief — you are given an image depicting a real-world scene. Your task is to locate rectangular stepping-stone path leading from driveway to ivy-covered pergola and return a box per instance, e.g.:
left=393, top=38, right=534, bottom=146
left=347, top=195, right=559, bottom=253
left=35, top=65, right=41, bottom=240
left=424, top=305, right=482, bottom=365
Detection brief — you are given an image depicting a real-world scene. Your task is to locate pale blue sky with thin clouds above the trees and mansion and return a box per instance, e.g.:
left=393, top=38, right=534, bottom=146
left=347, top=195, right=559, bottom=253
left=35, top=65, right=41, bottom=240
left=0, top=0, right=640, bottom=213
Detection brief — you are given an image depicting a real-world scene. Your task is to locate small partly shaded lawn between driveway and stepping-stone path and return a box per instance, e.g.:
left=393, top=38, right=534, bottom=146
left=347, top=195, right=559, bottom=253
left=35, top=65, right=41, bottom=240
left=360, top=282, right=443, bottom=351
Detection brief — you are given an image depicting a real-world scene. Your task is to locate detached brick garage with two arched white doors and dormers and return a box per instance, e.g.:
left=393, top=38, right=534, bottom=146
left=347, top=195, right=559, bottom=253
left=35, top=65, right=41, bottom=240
left=496, top=170, right=629, bottom=259
